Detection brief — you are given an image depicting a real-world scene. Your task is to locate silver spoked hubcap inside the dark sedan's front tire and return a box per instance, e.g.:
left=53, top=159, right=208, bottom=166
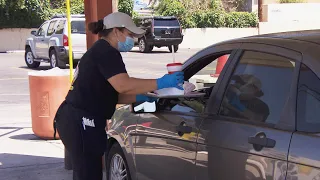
left=109, top=154, right=127, bottom=180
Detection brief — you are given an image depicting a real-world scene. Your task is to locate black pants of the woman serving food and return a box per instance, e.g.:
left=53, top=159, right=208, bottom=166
left=55, top=103, right=107, bottom=180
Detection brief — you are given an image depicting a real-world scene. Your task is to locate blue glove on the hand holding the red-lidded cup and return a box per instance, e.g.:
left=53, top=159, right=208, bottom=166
left=157, top=72, right=184, bottom=90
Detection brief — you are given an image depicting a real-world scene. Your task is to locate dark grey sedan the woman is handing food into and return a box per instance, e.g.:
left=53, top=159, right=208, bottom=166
left=105, top=30, right=320, bottom=180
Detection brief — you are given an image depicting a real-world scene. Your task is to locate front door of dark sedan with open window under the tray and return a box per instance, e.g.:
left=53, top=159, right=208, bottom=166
left=135, top=46, right=237, bottom=180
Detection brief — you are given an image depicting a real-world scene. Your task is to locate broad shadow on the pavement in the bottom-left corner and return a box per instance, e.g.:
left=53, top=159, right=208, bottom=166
left=0, top=153, right=72, bottom=180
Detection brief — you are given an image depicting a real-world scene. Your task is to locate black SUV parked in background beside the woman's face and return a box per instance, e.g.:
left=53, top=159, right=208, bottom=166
left=136, top=16, right=183, bottom=52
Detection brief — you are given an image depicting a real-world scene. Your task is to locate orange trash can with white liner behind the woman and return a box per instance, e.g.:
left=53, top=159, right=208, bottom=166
left=29, top=70, right=70, bottom=140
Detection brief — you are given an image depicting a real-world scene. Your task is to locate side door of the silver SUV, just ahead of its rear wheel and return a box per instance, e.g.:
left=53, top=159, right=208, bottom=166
left=35, top=22, right=49, bottom=58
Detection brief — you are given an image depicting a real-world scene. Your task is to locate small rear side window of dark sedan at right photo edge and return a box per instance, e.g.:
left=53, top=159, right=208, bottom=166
left=297, top=65, right=320, bottom=132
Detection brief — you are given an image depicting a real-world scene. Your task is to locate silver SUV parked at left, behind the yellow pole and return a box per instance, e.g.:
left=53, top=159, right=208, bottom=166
left=25, top=15, right=87, bottom=68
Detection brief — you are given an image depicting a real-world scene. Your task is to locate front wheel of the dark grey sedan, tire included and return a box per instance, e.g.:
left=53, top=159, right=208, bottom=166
left=106, top=143, right=131, bottom=180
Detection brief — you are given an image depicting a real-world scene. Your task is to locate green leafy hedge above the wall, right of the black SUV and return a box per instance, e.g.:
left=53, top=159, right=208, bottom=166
left=156, top=0, right=258, bottom=28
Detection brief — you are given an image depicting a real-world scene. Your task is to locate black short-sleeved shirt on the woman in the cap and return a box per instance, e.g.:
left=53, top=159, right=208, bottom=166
left=66, top=39, right=127, bottom=119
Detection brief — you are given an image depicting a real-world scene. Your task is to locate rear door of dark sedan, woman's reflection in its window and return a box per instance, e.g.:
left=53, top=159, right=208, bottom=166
left=196, top=43, right=301, bottom=180
